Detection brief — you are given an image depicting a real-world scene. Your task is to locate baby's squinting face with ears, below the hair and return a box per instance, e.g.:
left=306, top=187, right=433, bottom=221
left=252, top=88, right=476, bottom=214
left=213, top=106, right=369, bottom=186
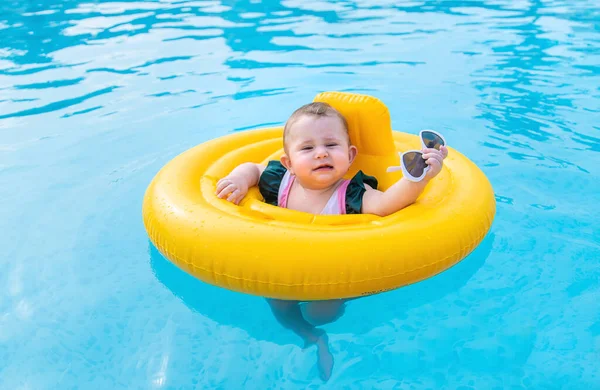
left=281, top=115, right=356, bottom=189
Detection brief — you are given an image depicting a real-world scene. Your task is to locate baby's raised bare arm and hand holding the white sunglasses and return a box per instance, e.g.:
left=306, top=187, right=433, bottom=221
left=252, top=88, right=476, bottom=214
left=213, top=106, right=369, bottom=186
left=362, top=146, right=448, bottom=217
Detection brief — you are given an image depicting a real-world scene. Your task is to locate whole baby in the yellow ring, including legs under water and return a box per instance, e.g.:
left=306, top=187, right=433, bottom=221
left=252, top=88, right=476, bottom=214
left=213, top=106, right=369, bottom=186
left=216, top=103, right=448, bottom=380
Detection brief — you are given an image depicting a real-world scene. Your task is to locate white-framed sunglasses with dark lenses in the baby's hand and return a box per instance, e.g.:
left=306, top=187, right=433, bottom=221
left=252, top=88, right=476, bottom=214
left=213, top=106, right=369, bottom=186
left=387, top=130, right=446, bottom=182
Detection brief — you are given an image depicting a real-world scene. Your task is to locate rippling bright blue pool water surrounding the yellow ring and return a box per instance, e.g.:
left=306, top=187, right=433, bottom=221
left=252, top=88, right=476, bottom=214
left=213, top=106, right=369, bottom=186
left=0, top=0, right=600, bottom=389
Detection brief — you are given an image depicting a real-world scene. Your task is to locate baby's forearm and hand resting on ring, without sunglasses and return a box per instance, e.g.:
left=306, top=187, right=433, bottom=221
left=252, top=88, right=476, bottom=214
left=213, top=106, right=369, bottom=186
left=217, top=163, right=266, bottom=204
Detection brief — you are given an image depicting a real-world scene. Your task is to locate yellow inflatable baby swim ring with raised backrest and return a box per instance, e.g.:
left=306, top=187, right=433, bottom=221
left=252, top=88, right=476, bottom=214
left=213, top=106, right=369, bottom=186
left=142, top=92, right=496, bottom=300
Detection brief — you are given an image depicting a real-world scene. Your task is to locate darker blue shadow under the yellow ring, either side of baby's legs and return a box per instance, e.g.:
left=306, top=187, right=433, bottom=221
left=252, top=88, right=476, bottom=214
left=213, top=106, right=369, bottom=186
left=148, top=233, right=495, bottom=343
